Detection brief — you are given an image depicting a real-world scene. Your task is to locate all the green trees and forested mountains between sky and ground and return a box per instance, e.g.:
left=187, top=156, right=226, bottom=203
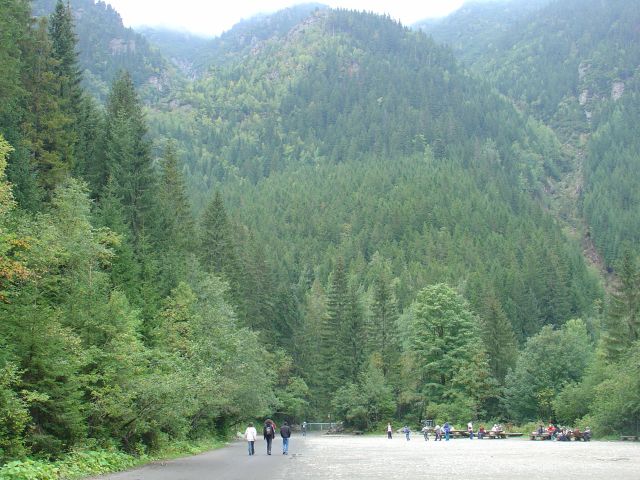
left=0, top=0, right=640, bottom=472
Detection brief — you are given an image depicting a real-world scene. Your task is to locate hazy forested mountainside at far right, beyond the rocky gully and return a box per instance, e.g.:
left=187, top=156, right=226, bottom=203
left=425, top=0, right=640, bottom=268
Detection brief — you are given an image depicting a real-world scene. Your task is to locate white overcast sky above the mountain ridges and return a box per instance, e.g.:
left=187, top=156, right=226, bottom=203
left=106, top=0, right=464, bottom=35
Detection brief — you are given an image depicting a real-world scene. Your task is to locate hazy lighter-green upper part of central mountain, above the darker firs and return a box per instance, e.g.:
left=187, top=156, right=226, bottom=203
left=150, top=11, right=566, bottom=197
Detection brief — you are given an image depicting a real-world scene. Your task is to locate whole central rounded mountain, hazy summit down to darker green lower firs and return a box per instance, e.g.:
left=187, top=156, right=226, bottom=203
left=149, top=6, right=599, bottom=390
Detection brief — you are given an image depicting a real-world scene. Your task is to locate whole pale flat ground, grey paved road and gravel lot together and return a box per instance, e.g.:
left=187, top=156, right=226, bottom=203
left=90, top=435, right=640, bottom=480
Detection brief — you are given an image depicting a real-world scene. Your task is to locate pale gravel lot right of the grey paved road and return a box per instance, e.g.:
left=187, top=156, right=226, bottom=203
left=287, top=435, right=640, bottom=480
